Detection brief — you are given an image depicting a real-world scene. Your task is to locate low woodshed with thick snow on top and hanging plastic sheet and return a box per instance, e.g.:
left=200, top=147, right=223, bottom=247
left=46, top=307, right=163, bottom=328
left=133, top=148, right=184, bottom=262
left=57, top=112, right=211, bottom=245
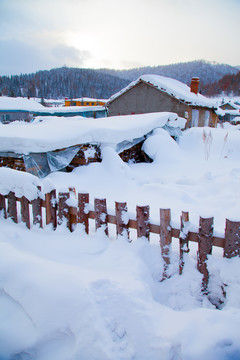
left=0, top=112, right=185, bottom=177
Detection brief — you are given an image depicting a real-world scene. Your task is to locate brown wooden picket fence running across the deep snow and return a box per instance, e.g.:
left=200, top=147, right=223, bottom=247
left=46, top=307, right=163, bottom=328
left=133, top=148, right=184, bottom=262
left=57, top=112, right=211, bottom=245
left=0, top=187, right=240, bottom=292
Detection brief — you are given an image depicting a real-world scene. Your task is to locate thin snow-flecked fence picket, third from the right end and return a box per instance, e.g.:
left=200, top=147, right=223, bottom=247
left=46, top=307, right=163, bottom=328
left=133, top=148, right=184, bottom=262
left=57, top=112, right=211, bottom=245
left=179, top=211, right=189, bottom=275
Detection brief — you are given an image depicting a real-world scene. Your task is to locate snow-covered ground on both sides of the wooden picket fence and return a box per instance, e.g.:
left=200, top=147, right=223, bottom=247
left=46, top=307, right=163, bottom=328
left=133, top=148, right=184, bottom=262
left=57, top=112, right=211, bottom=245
left=0, top=119, right=240, bottom=360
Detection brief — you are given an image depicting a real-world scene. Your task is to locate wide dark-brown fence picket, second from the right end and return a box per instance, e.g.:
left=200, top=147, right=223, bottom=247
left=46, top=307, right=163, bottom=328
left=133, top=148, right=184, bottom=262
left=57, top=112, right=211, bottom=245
left=198, top=217, right=213, bottom=292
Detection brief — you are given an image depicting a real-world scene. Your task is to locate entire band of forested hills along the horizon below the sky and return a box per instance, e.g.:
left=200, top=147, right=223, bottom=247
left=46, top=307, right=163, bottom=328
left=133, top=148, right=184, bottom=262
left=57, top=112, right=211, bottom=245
left=0, top=60, right=240, bottom=99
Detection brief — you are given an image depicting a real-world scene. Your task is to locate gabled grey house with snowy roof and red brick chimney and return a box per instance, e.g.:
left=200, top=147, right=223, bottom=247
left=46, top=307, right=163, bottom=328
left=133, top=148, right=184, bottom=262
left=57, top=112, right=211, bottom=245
left=106, top=75, right=218, bottom=128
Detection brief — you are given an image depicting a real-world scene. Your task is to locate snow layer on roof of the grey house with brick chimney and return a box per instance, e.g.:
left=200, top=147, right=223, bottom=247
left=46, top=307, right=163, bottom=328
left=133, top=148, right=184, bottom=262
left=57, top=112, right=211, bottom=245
left=107, top=75, right=218, bottom=108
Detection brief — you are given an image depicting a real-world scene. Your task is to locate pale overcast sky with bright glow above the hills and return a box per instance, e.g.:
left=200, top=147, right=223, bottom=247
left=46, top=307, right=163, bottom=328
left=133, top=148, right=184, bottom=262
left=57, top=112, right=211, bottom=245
left=0, top=0, right=240, bottom=75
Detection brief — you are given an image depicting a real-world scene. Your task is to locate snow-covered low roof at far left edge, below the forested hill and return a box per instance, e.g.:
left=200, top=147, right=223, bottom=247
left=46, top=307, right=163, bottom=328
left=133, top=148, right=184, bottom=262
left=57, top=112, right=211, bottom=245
left=0, top=96, right=46, bottom=111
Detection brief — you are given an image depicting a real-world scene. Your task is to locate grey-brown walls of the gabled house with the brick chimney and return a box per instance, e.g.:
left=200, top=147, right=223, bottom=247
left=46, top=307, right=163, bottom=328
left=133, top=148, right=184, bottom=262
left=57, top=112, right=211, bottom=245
left=108, top=82, right=217, bottom=128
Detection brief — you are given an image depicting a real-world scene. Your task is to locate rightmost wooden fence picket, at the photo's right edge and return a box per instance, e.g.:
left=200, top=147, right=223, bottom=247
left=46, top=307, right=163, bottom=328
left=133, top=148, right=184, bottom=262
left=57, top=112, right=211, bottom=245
left=223, top=219, right=240, bottom=258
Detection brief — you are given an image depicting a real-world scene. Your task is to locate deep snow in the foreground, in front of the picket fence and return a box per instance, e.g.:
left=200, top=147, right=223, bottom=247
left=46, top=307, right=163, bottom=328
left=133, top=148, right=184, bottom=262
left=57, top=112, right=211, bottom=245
left=0, top=220, right=240, bottom=360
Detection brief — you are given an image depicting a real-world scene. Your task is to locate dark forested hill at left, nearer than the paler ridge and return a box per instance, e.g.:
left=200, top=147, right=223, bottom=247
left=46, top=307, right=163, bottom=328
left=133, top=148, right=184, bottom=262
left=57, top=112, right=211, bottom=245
left=0, top=67, right=129, bottom=99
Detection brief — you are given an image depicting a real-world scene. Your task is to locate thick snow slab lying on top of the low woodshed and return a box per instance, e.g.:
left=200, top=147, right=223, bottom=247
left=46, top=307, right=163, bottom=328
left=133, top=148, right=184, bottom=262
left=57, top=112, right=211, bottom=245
left=0, top=112, right=186, bottom=154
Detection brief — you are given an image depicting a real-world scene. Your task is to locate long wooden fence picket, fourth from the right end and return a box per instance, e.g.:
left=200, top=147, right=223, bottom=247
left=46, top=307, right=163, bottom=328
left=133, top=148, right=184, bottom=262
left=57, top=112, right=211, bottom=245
left=160, top=209, right=172, bottom=280
